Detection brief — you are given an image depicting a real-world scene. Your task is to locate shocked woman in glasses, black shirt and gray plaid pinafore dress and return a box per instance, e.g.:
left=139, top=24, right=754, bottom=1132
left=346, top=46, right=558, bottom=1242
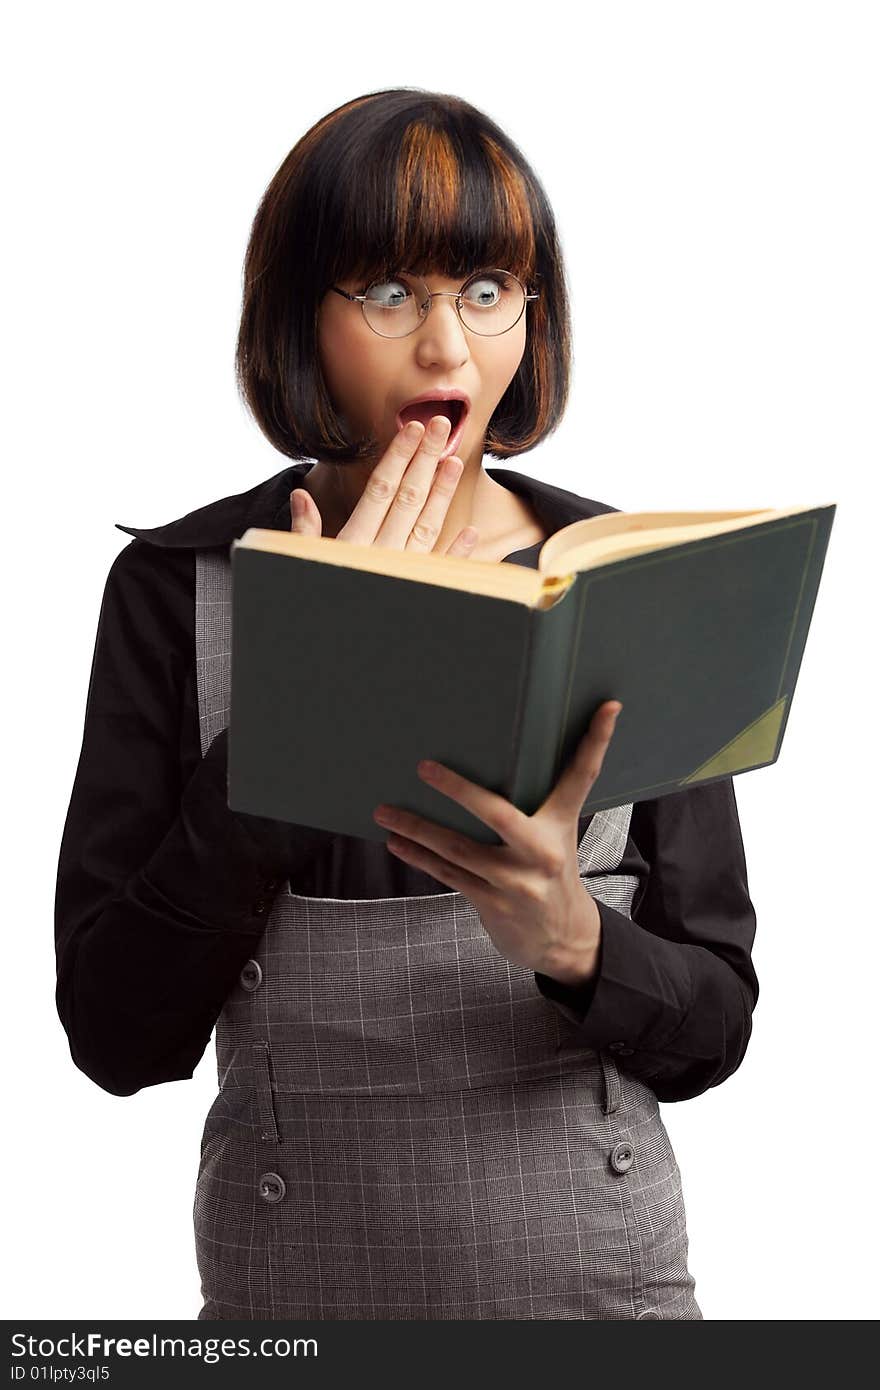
left=56, top=89, right=758, bottom=1319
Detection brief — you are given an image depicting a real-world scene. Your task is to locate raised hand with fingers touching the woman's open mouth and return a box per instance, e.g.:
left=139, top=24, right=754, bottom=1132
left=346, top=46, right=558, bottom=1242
left=291, top=416, right=478, bottom=559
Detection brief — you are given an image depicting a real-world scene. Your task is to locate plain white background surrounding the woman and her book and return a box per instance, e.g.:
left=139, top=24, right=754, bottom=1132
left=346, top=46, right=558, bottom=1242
left=1, top=0, right=880, bottom=1319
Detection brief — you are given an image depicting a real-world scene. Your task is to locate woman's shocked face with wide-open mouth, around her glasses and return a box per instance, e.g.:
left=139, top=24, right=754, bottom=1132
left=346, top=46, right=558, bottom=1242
left=318, top=265, right=528, bottom=468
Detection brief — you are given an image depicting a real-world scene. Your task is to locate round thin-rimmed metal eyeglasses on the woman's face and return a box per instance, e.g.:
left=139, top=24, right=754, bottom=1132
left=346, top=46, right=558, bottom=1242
left=331, top=270, right=538, bottom=338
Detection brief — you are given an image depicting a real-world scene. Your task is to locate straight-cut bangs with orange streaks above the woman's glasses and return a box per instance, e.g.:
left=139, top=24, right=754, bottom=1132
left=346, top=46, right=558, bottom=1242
left=312, top=110, right=535, bottom=288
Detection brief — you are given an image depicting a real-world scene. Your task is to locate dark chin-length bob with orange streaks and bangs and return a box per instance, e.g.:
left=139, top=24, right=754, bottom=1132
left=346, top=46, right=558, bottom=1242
left=235, top=88, right=571, bottom=463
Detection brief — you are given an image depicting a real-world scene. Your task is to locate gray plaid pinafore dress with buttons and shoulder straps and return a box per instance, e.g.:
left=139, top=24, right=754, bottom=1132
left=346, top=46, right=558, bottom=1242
left=193, top=550, right=702, bottom=1321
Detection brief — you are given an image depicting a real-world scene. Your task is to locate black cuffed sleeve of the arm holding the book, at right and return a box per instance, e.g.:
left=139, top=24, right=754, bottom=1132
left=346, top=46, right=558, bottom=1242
left=535, top=777, right=758, bottom=1101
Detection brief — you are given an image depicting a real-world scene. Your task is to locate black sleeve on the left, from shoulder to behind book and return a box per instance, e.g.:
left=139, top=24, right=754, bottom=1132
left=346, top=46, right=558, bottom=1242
left=54, top=539, right=332, bottom=1095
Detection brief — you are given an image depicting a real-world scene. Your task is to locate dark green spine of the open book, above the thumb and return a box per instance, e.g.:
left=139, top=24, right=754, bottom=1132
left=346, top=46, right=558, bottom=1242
left=507, top=581, right=582, bottom=816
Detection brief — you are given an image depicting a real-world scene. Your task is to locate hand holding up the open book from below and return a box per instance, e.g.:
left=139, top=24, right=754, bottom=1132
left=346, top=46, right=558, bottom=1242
left=374, top=701, right=623, bottom=984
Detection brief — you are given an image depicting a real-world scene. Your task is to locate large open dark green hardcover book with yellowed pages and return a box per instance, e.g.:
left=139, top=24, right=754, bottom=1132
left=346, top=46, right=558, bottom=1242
left=228, top=505, right=836, bottom=844
